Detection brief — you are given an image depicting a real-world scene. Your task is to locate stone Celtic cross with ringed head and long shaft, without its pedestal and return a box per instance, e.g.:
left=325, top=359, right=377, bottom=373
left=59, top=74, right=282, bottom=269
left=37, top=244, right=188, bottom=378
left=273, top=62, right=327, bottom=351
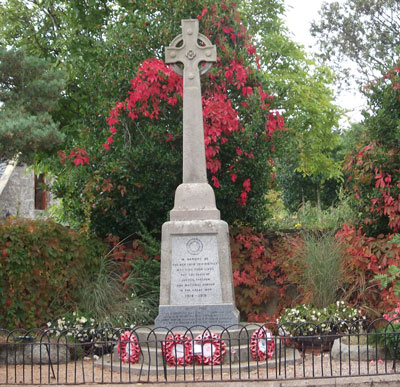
left=165, top=19, right=217, bottom=183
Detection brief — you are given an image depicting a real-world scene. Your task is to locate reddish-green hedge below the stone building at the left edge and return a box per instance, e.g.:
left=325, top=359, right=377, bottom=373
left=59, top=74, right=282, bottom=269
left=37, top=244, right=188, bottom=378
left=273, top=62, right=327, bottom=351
left=0, top=218, right=104, bottom=329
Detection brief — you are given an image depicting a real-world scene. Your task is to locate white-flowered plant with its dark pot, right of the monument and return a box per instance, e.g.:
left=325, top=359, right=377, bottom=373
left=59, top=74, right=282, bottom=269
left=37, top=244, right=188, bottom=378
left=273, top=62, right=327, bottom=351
left=277, top=301, right=365, bottom=353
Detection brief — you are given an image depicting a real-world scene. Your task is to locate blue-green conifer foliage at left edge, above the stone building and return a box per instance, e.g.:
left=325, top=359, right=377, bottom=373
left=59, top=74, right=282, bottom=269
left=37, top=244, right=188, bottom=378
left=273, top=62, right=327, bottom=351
left=0, top=47, right=64, bottom=164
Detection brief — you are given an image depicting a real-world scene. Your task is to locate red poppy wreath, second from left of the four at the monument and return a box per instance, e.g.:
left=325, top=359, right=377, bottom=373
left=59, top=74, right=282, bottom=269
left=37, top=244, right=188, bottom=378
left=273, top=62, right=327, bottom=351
left=161, top=333, right=193, bottom=366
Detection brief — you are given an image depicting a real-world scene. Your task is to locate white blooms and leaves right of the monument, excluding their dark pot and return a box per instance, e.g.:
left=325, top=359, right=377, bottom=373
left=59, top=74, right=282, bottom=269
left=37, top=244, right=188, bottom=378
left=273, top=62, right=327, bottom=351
left=277, top=301, right=365, bottom=336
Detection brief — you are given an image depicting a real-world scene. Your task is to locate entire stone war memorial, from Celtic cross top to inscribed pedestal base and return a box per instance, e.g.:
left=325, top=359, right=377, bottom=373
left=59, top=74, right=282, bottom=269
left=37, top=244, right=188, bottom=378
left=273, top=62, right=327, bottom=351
left=155, top=20, right=239, bottom=328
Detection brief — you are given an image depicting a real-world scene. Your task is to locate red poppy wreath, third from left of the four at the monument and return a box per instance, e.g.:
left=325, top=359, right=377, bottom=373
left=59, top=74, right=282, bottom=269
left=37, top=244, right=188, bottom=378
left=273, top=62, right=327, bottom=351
left=194, top=332, right=226, bottom=365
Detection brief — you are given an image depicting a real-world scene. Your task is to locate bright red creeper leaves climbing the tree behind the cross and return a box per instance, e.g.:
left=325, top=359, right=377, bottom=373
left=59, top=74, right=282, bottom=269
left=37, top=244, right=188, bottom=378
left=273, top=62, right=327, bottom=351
left=58, top=1, right=284, bottom=212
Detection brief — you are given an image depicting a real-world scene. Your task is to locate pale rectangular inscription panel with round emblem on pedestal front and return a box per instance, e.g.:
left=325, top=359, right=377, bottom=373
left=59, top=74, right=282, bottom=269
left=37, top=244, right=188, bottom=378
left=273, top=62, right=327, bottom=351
left=171, top=234, right=222, bottom=305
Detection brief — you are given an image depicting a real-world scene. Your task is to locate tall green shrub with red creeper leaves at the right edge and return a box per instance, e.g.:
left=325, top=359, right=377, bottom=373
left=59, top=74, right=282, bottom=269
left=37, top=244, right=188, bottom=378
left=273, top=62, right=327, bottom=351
left=344, top=62, right=400, bottom=237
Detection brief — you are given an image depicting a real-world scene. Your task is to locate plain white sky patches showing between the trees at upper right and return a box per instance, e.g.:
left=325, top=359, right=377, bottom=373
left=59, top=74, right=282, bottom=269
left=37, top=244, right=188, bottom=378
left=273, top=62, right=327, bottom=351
left=285, top=0, right=365, bottom=126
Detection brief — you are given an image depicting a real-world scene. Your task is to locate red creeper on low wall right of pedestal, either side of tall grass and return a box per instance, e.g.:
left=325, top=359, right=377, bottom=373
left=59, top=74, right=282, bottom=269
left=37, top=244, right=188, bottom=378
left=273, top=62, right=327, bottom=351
left=231, top=225, right=400, bottom=322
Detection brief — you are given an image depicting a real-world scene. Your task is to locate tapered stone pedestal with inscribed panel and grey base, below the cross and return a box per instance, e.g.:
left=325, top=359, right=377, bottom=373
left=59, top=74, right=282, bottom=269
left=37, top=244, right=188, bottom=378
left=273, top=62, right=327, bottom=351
left=156, top=220, right=239, bottom=328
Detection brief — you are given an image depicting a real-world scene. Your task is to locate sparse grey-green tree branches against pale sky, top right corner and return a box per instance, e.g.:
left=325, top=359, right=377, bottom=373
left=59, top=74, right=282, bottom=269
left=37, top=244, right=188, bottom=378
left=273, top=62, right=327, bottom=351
left=311, top=0, right=400, bottom=83
